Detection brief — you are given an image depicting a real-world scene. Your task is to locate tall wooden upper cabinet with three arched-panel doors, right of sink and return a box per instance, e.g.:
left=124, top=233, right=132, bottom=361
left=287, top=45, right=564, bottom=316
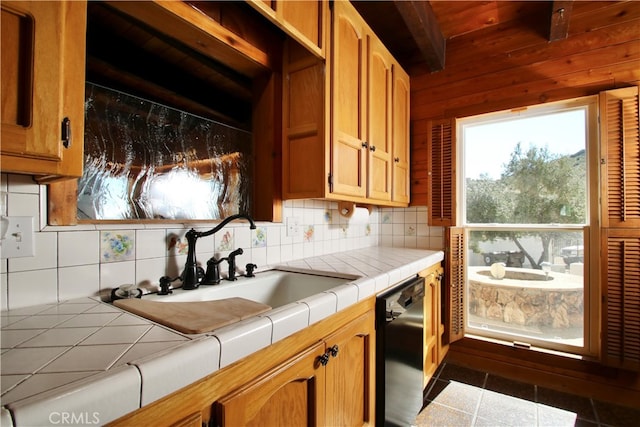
left=282, top=1, right=409, bottom=206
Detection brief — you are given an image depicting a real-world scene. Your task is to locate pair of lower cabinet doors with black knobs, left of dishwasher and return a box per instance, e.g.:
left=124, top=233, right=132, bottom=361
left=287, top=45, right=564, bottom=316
left=214, top=312, right=375, bottom=426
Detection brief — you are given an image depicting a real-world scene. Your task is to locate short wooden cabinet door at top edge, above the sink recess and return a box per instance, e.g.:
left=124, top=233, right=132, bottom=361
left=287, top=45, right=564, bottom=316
left=247, top=0, right=329, bottom=58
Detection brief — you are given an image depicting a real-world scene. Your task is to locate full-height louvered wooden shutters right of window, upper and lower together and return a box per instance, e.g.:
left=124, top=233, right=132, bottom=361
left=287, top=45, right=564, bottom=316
left=600, top=87, right=640, bottom=371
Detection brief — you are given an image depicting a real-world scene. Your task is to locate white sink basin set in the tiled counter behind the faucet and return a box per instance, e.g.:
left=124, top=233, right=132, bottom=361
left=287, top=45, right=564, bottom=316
left=143, top=270, right=358, bottom=308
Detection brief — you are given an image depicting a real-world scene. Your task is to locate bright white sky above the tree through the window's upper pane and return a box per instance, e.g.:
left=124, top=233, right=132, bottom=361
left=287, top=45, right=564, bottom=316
left=463, top=109, right=586, bottom=179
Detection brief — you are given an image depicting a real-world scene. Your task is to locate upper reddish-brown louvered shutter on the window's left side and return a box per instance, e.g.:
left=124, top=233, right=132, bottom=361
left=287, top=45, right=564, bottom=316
left=427, top=119, right=456, bottom=227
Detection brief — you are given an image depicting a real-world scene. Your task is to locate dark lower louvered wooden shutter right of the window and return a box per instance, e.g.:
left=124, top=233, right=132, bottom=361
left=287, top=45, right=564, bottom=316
left=602, top=229, right=640, bottom=370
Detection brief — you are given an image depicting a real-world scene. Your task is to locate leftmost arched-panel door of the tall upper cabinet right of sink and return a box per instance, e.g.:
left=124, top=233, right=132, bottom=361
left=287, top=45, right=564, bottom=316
left=331, top=1, right=367, bottom=198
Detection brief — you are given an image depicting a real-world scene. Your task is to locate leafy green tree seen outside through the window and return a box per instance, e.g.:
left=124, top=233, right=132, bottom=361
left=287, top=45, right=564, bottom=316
left=466, top=143, right=586, bottom=268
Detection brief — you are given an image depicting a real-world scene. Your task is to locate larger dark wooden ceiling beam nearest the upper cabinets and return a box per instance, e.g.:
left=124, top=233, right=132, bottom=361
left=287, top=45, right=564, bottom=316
left=393, top=0, right=446, bottom=72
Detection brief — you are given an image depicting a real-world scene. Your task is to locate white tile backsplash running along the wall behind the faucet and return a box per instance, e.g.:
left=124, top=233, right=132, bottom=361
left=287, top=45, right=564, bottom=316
left=0, top=174, right=443, bottom=310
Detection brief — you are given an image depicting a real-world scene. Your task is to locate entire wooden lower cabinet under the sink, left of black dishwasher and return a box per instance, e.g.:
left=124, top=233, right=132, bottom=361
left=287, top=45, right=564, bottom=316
left=109, top=297, right=376, bottom=426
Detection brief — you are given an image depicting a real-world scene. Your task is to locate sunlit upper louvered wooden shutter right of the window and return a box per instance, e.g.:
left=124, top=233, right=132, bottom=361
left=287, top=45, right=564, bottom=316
left=600, top=87, right=640, bottom=227
